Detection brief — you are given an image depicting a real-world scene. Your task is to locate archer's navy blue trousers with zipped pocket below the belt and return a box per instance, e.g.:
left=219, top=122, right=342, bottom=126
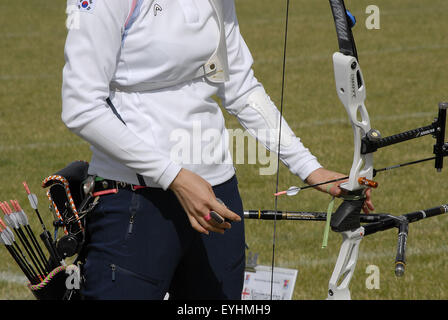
left=82, top=177, right=245, bottom=300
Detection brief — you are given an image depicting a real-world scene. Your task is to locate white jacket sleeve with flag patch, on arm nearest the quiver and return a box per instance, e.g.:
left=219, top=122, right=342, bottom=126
left=62, top=0, right=181, bottom=189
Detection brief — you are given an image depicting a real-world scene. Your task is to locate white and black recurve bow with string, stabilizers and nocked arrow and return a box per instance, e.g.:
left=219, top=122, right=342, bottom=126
left=250, top=0, right=448, bottom=299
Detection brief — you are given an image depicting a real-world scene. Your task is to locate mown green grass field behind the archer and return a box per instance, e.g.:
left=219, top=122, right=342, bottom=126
left=0, top=0, right=448, bottom=299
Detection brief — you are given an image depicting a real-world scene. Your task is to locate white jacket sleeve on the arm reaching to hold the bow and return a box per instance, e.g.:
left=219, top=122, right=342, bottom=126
left=219, top=1, right=322, bottom=180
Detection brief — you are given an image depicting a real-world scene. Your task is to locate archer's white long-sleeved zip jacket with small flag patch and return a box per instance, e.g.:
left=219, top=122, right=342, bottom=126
left=62, top=0, right=321, bottom=189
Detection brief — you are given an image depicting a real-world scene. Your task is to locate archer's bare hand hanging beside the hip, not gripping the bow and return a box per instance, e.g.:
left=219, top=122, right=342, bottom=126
left=169, top=169, right=241, bottom=235
